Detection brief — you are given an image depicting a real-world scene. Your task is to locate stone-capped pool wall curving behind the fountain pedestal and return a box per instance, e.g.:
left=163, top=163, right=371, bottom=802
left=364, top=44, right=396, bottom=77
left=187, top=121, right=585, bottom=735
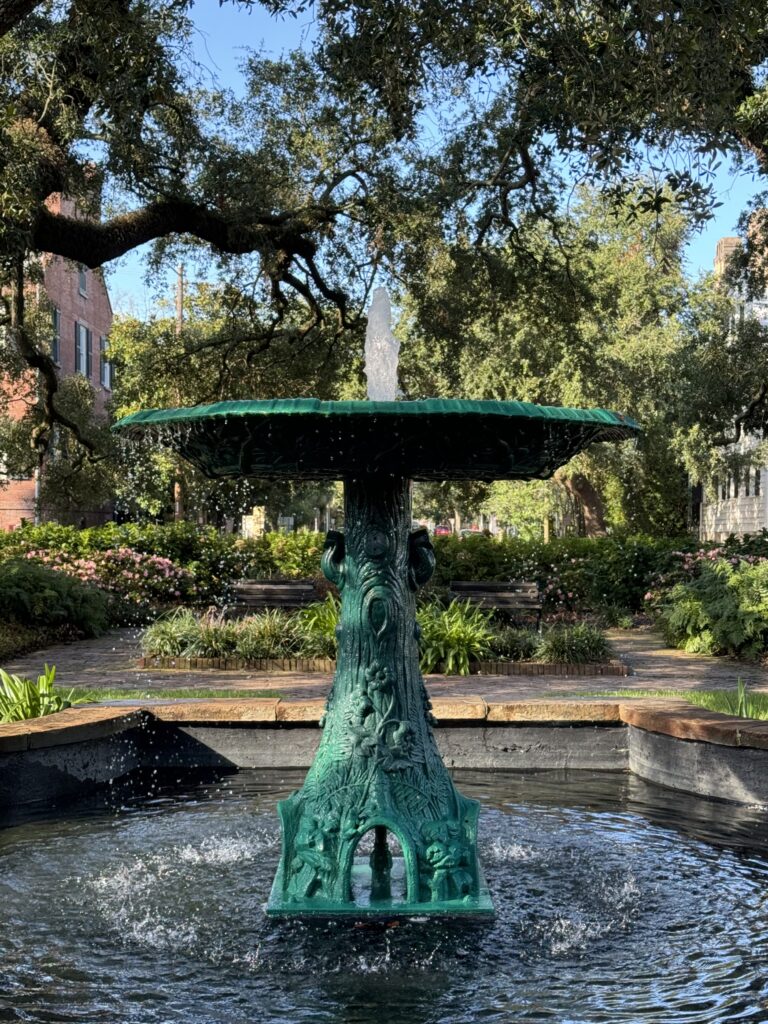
left=0, top=695, right=768, bottom=814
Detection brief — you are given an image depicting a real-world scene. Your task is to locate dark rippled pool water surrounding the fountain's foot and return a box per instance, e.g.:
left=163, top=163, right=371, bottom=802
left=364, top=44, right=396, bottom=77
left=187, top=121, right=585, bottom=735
left=0, top=772, right=768, bottom=1024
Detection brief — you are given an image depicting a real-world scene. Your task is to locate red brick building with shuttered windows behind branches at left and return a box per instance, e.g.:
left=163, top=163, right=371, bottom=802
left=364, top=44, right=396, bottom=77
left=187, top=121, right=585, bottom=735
left=0, top=197, right=113, bottom=529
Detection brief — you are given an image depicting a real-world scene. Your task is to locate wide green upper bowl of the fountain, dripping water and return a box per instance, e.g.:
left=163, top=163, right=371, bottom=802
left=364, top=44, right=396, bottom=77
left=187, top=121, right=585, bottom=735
left=113, top=398, right=640, bottom=480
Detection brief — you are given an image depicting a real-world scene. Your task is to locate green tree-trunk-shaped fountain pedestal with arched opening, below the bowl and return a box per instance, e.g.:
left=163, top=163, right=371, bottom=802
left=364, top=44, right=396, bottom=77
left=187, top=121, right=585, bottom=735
left=267, top=475, right=493, bottom=916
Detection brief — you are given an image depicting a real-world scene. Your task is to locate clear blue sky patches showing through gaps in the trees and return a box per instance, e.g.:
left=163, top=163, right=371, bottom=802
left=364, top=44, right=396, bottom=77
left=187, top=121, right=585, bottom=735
left=108, top=0, right=765, bottom=317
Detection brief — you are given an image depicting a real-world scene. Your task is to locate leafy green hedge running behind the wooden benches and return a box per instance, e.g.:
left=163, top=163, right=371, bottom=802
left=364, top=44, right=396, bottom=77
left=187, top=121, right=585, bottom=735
left=15, top=522, right=768, bottom=612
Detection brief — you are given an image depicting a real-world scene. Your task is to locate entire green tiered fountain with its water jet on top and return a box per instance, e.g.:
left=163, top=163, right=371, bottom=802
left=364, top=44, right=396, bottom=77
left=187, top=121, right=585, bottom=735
left=115, top=288, right=638, bottom=919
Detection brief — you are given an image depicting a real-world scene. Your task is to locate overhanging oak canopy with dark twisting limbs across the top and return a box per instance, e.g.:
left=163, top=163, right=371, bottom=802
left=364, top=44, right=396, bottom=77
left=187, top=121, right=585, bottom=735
left=0, top=0, right=768, bottom=524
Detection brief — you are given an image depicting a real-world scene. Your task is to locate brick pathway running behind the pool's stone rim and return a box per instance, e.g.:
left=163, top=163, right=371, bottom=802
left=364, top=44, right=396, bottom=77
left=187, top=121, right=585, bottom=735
left=3, top=629, right=768, bottom=700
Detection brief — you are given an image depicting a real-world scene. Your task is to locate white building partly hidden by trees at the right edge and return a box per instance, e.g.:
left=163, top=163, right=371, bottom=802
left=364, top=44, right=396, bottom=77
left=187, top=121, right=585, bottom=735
left=699, top=238, right=768, bottom=541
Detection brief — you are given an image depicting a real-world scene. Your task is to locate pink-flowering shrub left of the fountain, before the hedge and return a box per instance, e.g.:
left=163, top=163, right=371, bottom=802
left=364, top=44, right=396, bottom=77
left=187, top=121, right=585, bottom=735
left=27, top=548, right=196, bottom=607
